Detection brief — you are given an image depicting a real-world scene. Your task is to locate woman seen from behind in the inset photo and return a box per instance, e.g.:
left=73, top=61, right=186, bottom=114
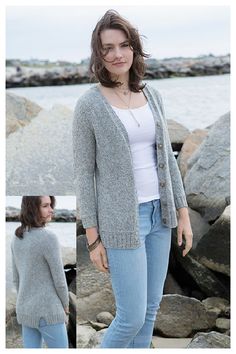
left=11, top=196, right=69, bottom=348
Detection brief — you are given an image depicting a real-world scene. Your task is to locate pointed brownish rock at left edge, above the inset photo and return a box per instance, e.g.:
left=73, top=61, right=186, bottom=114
left=6, top=92, right=42, bottom=136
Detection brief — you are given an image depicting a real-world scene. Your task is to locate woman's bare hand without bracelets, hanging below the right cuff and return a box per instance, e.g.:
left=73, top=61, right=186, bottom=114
left=177, top=208, right=193, bottom=257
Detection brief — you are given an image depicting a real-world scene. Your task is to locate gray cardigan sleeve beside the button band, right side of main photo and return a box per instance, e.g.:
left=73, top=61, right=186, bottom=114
left=156, top=92, right=188, bottom=209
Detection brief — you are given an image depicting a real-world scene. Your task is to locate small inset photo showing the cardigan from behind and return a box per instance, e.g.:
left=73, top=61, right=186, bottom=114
left=6, top=196, right=76, bottom=348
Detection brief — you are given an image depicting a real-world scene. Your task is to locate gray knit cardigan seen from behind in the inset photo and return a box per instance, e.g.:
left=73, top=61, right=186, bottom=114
left=11, top=228, right=69, bottom=328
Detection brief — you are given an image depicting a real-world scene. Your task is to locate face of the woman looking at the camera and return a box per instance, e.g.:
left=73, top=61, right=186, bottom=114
left=100, top=29, right=133, bottom=78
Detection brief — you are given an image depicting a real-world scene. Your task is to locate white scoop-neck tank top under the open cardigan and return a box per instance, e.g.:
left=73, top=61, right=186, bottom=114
left=112, top=102, right=160, bottom=203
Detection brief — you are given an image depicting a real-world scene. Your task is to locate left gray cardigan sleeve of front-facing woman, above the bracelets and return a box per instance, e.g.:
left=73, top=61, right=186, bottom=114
left=72, top=100, right=98, bottom=229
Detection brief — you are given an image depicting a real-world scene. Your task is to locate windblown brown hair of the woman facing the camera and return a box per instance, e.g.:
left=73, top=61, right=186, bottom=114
left=89, top=10, right=149, bottom=92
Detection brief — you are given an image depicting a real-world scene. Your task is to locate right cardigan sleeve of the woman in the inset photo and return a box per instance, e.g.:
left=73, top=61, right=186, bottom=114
left=42, top=231, right=69, bottom=308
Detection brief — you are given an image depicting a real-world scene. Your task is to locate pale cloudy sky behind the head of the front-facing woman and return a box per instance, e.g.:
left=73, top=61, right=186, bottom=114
left=6, top=5, right=230, bottom=62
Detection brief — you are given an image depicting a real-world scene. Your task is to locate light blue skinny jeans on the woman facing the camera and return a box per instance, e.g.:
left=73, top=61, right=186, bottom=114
left=100, top=199, right=171, bottom=348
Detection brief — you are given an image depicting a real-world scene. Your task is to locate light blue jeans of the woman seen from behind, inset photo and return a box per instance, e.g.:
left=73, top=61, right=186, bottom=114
left=22, top=318, right=68, bottom=348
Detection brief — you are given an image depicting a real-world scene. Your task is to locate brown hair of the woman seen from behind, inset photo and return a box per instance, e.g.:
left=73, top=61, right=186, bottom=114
left=15, top=195, right=56, bottom=238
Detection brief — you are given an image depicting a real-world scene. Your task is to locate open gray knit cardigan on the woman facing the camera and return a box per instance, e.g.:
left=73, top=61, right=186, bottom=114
left=73, top=84, right=187, bottom=248
